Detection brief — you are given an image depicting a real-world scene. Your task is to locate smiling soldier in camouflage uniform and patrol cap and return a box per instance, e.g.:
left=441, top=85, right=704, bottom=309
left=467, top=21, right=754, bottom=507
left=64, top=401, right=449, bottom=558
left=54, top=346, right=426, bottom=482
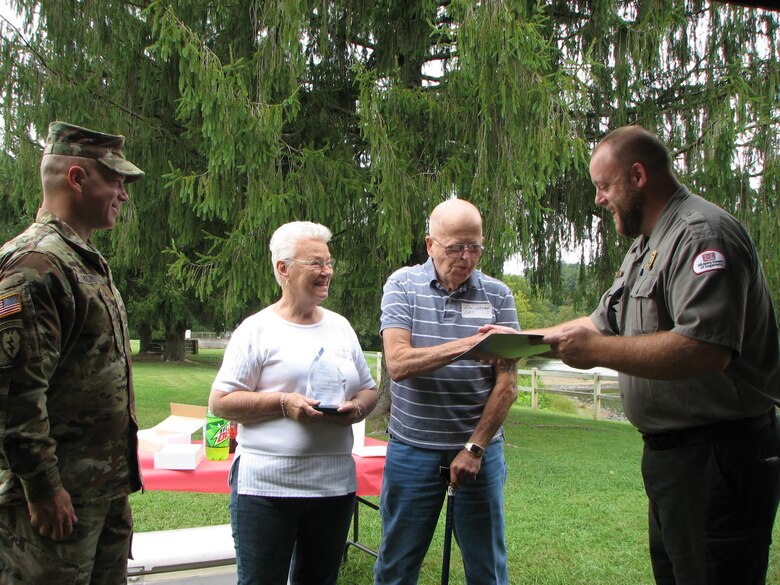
left=0, top=122, right=144, bottom=585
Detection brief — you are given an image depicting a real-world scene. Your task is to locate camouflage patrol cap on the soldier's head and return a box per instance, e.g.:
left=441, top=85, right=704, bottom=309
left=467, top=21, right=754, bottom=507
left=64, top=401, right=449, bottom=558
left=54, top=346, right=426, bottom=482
left=43, top=122, right=144, bottom=183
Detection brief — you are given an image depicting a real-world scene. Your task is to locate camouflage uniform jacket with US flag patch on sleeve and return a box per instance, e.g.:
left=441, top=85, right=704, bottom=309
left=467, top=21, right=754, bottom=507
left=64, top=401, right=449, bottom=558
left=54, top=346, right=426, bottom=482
left=0, top=211, right=141, bottom=505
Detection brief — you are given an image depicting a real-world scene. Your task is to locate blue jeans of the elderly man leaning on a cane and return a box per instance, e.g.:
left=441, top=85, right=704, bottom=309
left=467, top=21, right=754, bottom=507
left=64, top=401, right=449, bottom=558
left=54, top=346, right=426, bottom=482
left=374, top=439, right=509, bottom=585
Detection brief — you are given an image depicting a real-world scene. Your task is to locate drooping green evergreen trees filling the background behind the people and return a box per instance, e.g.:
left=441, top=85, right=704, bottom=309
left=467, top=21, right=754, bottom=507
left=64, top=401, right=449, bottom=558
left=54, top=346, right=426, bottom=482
left=0, top=0, right=780, bottom=359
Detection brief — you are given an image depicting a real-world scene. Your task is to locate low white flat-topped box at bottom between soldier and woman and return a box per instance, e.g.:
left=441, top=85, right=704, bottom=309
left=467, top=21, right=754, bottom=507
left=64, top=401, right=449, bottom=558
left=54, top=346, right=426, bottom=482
left=127, top=524, right=236, bottom=585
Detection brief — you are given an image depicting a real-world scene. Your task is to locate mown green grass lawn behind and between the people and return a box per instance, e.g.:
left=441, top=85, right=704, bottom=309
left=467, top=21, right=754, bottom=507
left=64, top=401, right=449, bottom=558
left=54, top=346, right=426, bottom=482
left=131, top=350, right=780, bottom=585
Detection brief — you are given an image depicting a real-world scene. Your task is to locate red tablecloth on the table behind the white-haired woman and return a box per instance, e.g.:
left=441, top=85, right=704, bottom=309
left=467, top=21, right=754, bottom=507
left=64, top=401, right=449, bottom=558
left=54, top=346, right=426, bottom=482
left=138, top=437, right=385, bottom=496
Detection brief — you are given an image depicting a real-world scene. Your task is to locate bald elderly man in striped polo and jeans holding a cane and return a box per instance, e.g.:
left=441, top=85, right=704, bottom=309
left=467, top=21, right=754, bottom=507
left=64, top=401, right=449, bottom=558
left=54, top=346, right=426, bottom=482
left=374, top=199, right=519, bottom=585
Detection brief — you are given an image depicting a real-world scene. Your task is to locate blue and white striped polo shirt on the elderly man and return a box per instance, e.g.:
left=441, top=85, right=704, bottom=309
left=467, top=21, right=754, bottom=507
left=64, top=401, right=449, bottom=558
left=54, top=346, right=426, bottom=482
left=380, top=258, right=520, bottom=449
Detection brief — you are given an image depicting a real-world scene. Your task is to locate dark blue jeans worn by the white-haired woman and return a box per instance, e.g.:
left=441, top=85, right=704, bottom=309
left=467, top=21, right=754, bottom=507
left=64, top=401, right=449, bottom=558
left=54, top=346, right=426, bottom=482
left=230, top=461, right=355, bottom=585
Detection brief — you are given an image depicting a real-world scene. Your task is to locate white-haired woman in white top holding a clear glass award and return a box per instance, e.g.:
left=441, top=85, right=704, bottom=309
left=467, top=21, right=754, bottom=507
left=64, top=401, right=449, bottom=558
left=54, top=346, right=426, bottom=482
left=209, top=221, right=378, bottom=585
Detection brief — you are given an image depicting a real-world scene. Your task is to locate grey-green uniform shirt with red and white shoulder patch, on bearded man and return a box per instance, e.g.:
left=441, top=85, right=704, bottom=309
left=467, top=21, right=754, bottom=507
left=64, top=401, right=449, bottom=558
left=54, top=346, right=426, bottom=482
left=591, top=187, right=780, bottom=433
